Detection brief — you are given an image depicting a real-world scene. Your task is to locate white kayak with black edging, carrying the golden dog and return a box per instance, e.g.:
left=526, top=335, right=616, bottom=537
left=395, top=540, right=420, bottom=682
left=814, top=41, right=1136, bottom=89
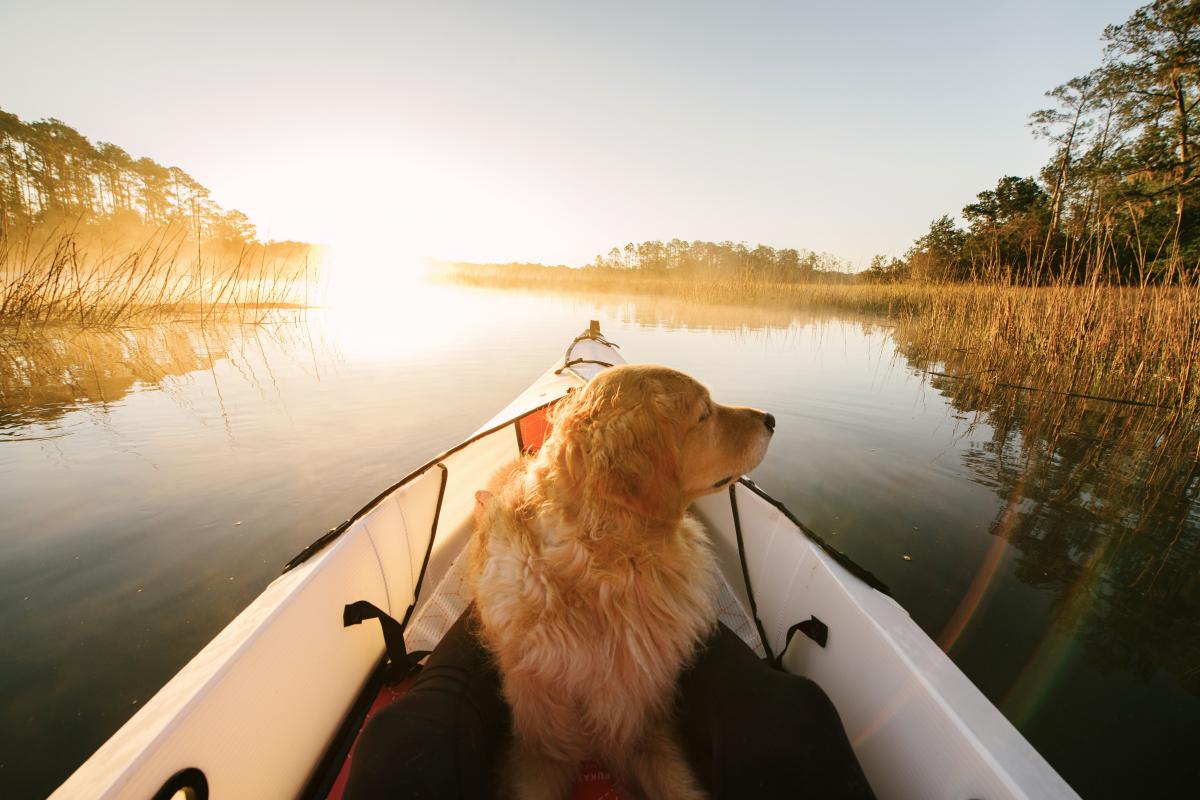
left=53, top=323, right=1078, bottom=800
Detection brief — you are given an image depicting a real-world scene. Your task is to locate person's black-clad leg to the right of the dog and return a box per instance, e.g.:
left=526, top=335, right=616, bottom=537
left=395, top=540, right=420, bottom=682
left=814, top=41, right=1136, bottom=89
left=679, top=625, right=875, bottom=800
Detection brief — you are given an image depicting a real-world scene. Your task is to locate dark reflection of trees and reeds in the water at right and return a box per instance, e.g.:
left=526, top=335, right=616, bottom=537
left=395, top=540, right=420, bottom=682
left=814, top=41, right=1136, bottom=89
left=896, top=329, right=1200, bottom=796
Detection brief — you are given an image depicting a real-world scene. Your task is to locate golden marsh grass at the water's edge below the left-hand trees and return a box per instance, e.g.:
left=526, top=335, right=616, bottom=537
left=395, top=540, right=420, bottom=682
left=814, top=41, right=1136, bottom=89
left=0, top=229, right=316, bottom=333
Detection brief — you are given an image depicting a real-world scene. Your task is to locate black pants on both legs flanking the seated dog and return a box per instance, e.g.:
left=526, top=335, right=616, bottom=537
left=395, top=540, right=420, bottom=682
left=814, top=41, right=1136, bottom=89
left=344, top=615, right=874, bottom=800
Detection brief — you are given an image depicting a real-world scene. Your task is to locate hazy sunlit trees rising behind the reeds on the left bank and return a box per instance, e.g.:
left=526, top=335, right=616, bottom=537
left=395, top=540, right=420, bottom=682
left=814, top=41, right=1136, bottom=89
left=0, top=109, right=256, bottom=242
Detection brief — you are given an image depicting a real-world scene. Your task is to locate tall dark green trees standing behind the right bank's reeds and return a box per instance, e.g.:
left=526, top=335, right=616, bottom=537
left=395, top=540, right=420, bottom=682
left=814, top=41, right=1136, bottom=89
left=865, top=0, right=1200, bottom=283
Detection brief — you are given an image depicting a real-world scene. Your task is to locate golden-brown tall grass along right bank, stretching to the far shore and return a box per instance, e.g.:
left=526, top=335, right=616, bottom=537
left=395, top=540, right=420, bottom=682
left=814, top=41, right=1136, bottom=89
left=440, top=265, right=1200, bottom=414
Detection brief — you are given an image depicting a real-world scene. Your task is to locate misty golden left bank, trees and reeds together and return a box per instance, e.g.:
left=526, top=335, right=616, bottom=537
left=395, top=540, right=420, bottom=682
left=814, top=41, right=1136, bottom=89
left=0, top=110, right=322, bottom=331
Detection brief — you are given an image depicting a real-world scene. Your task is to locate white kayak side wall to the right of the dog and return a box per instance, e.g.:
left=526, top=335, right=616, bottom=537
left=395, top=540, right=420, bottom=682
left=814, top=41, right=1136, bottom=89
left=696, top=481, right=1079, bottom=800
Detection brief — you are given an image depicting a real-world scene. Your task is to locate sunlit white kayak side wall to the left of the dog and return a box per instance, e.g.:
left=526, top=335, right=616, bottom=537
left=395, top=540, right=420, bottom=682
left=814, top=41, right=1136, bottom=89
left=52, top=425, right=518, bottom=800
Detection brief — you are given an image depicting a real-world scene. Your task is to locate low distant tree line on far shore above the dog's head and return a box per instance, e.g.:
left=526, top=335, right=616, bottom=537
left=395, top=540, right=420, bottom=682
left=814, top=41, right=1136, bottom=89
left=588, top=239, right=853, bottom=283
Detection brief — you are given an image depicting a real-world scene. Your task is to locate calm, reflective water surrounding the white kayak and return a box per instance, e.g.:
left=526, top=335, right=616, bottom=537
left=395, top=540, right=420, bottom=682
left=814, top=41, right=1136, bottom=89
left=0, top=280, right=1200, bottom=798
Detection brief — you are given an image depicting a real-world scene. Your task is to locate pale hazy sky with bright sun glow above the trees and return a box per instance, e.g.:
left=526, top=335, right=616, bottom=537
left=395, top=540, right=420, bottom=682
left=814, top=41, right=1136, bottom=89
left=0, top=0, right=1142, bottom=265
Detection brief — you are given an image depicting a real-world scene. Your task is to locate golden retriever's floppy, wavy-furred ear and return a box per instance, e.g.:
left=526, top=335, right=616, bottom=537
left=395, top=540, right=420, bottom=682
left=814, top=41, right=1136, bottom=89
left=553, top=383, right=684, bottom=519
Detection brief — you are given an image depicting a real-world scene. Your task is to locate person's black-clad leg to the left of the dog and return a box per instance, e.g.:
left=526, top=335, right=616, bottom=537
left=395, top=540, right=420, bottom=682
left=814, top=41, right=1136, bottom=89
left=344, top=610, right=510, bottom=800
